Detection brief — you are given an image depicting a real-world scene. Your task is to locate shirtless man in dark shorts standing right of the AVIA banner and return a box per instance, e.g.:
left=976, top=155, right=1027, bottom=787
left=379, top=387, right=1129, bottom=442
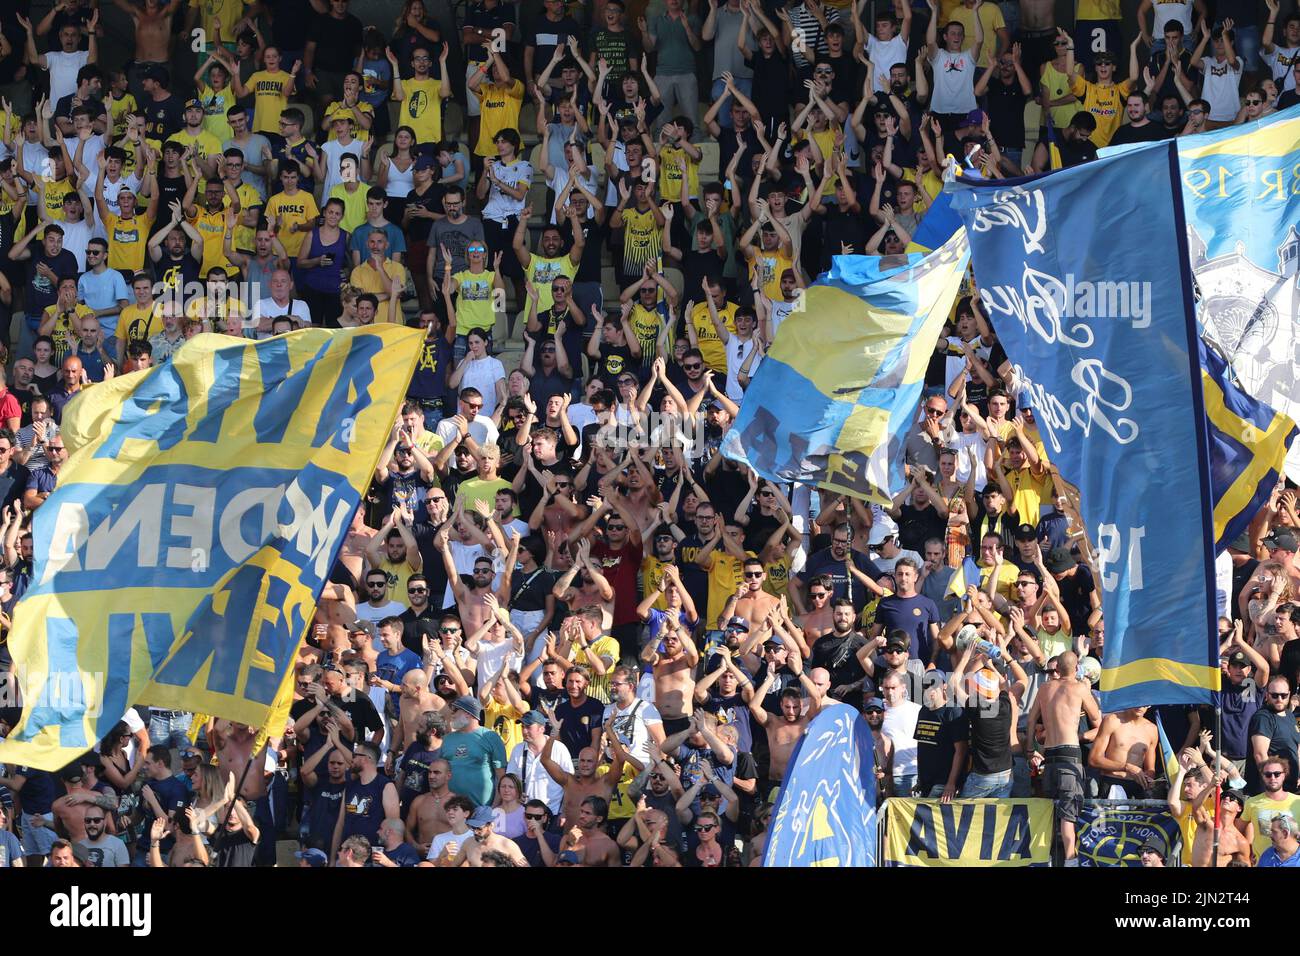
left=1028, top=650, right=1101, bottom=866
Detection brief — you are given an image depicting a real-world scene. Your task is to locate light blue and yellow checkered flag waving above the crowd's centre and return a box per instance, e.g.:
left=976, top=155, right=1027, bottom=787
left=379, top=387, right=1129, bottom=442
left=722, top=232, right=969, bottom=503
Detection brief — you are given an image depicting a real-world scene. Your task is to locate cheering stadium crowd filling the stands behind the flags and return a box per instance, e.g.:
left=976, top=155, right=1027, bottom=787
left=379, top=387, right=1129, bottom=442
left=0, top=0, right=1300, bottom=868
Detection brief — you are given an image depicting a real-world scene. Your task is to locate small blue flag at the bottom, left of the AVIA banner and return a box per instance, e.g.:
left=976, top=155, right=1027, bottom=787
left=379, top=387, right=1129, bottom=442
left=763, top=704, right=876, bottom=866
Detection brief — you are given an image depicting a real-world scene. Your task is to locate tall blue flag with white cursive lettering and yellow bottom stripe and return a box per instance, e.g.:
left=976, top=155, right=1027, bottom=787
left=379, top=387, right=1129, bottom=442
left=953, top=144, right=1219, bottom=711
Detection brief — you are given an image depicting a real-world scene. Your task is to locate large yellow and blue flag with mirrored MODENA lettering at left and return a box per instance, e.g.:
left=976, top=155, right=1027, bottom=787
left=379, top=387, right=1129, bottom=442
left=0, top=325, right=423, bottom=770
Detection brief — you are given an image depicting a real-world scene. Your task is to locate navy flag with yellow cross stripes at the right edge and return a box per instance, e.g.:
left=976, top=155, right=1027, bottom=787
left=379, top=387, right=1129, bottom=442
left=1201, top=339, right=1296, bottom=553
